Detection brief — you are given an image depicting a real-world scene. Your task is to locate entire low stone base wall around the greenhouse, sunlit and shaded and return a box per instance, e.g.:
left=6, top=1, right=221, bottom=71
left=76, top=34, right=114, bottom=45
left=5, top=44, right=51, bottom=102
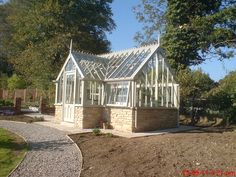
left=55, top=105, right=178, bottom=132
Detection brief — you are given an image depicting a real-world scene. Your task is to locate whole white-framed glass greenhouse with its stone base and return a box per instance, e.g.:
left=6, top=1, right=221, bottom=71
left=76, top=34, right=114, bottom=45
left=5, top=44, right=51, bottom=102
left=55, top=44, right=179, bottom=132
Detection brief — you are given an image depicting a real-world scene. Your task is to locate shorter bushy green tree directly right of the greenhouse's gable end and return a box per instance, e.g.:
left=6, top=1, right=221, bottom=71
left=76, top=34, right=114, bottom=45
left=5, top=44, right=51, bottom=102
left=178, top=69, right=215, bottom=124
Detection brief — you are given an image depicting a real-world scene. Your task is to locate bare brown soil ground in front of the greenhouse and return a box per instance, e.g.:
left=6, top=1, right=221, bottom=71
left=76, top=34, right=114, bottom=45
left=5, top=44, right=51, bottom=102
left=70, top=128, right=236, bottom=177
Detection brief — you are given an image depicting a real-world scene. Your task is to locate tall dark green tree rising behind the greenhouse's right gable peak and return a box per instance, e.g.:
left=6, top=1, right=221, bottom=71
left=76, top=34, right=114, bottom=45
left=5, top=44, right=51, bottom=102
left=135, top=0, right=236, bottom=69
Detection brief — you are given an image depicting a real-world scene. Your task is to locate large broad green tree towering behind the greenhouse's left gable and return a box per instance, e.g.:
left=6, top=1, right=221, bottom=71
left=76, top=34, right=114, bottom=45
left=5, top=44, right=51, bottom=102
left=0, top=0, right=115, bottom=90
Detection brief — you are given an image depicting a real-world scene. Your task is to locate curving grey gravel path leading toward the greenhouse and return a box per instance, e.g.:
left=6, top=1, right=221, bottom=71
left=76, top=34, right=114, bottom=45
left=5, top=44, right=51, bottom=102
left=0, top=121, right=82, bottom=177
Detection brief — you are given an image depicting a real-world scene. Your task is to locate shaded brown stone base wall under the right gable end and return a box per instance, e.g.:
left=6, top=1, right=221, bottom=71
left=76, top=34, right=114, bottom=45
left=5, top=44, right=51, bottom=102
left=134, top=108, right=178, bottom=132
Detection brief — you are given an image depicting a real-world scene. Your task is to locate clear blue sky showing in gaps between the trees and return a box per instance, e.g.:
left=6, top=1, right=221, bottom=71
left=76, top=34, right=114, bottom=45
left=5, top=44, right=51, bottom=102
left=107, top=0, right=236, bottom=81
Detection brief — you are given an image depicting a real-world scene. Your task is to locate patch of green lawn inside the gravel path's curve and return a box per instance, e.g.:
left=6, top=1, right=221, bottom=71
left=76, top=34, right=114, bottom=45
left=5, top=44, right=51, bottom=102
left=0, top=128, right=27, bottom=177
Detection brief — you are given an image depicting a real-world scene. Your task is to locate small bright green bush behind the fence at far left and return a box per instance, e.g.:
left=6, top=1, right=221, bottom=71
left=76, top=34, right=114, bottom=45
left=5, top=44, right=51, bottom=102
left=7, top=74, right=26, bottom=90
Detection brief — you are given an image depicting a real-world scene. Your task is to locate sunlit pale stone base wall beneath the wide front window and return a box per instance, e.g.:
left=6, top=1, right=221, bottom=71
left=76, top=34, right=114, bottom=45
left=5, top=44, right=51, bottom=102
left=104, top=107, right=134, bottom=132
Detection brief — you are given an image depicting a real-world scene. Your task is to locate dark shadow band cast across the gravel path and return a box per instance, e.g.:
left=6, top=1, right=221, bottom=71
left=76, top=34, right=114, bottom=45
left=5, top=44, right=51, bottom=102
left=29, top=140, right=73, bottom=151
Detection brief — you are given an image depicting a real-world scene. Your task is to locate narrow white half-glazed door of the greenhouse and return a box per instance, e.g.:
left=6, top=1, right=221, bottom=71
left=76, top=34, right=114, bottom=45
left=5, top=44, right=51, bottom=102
left=64, top=73, right=75, bottom=122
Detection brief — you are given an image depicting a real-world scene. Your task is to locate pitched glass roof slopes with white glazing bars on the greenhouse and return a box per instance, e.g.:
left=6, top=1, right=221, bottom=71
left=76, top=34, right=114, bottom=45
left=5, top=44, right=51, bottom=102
left=67, top=44, right=158, bottom=80
